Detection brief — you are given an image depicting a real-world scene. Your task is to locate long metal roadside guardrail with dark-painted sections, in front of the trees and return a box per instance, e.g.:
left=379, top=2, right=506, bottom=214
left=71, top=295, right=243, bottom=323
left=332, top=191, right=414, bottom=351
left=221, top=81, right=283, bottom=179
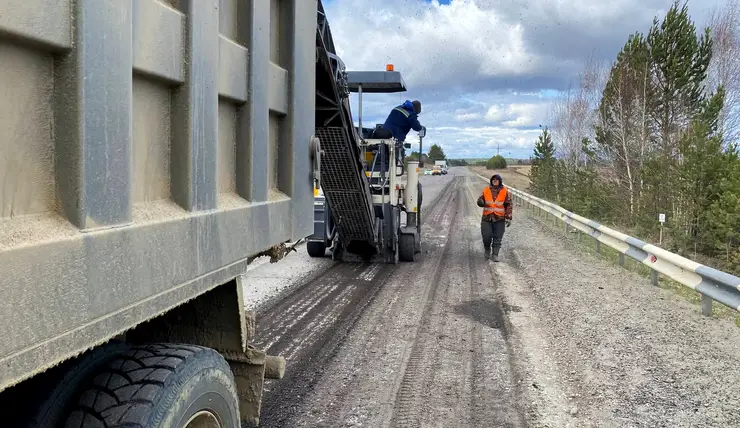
left=478, top=175, right=740, bottom=316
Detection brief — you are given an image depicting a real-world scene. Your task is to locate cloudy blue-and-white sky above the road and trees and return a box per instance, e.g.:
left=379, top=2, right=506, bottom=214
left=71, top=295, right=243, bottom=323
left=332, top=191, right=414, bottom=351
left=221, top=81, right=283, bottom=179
left=323, top=0, right=723, bottom=158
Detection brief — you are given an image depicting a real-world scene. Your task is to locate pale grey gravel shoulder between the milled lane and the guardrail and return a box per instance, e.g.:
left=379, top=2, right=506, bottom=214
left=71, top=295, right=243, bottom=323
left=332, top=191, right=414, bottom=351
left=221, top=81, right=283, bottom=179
left=506, top=195, right=740, bottom=427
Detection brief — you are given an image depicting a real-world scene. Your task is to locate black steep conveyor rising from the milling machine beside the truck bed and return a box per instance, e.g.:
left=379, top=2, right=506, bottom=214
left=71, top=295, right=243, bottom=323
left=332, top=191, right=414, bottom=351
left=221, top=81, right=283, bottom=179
left=316, top=0, right=378, bottom=253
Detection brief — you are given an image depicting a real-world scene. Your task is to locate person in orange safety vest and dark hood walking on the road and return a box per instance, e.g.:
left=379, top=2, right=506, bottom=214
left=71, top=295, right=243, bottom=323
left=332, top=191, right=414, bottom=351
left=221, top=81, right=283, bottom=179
left=478, top=174, right=512, bottom=262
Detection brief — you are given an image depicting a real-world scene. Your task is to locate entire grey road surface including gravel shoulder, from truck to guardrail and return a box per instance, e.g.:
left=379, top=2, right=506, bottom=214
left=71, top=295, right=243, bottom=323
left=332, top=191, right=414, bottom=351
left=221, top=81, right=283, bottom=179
left=247, top=168, right=740, bottom=427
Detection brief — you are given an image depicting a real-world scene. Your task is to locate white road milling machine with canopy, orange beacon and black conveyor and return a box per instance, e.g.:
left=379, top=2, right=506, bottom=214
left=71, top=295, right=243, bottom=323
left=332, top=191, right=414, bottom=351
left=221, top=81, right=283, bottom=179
left=306, top=12, right=424, bottom=264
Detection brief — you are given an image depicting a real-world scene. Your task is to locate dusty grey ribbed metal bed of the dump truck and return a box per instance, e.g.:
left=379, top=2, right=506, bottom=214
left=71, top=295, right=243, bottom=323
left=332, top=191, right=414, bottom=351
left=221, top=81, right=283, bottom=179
left=0, top=0, right=317, bottom=390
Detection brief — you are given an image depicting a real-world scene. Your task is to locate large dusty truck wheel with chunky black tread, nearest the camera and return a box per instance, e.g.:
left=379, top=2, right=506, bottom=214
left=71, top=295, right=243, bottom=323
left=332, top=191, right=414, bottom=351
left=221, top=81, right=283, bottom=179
left=64, top=344, right=240, bottom=428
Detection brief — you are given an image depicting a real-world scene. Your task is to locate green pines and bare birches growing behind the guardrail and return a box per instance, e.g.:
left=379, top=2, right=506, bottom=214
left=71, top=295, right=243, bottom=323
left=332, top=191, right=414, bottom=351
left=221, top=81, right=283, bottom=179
left=530, top=0, right=740, bottom=274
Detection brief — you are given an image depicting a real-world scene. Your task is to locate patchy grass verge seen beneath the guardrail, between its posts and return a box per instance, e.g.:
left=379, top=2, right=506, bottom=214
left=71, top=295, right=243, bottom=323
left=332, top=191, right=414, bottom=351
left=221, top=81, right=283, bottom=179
left=526, top=204, right=740, bottom=327
